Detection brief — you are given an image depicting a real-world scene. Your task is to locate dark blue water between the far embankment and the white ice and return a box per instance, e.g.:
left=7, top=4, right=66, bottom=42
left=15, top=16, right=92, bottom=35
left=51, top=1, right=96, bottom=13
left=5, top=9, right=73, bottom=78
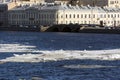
left=0, top=32, right=120, bottom=50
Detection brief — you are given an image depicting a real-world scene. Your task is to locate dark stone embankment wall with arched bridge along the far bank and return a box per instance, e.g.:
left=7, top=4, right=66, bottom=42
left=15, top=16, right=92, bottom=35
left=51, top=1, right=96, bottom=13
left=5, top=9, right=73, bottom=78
left=0, top=25, right=120, bottom=34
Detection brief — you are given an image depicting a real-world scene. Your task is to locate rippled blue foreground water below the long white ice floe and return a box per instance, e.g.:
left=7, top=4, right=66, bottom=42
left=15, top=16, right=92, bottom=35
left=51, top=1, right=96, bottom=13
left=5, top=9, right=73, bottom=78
left=0, top=59, right=120, bottom=80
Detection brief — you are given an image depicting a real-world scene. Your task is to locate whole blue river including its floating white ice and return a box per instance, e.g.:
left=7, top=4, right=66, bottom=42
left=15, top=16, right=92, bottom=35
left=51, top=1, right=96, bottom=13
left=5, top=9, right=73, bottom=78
left=0, top=31, right=120, bottom=80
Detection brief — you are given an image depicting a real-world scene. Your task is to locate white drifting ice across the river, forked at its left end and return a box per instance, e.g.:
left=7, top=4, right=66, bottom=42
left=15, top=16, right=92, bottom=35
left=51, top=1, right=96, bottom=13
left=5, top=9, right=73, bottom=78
left=0, top=44, right=120, bottom=62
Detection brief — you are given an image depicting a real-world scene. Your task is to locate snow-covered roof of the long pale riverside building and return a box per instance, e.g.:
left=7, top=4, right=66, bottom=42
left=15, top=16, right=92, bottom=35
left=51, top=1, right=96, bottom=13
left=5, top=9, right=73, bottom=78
left=9, top=3, right=120, bottom=12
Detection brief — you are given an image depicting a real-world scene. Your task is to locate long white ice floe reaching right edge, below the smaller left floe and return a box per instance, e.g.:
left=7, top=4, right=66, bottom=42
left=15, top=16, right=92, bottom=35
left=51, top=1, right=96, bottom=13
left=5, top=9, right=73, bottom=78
left=0, top=49, right=120, bottom=62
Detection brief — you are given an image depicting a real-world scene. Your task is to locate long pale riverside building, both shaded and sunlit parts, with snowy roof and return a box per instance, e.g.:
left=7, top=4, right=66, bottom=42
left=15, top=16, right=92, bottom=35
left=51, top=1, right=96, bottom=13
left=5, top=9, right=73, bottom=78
left=8, top=4, right=120, bottom=26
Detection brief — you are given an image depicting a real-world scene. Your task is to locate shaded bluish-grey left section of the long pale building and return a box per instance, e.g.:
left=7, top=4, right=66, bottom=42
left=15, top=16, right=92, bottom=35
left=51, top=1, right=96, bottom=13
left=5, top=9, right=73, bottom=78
left=8, top=5, right=56, bottom=26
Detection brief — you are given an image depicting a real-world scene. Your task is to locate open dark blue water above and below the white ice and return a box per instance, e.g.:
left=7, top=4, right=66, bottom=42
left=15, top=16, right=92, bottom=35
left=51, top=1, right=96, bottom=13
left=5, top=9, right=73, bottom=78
left=0, top=32, right=120, bottom=80
